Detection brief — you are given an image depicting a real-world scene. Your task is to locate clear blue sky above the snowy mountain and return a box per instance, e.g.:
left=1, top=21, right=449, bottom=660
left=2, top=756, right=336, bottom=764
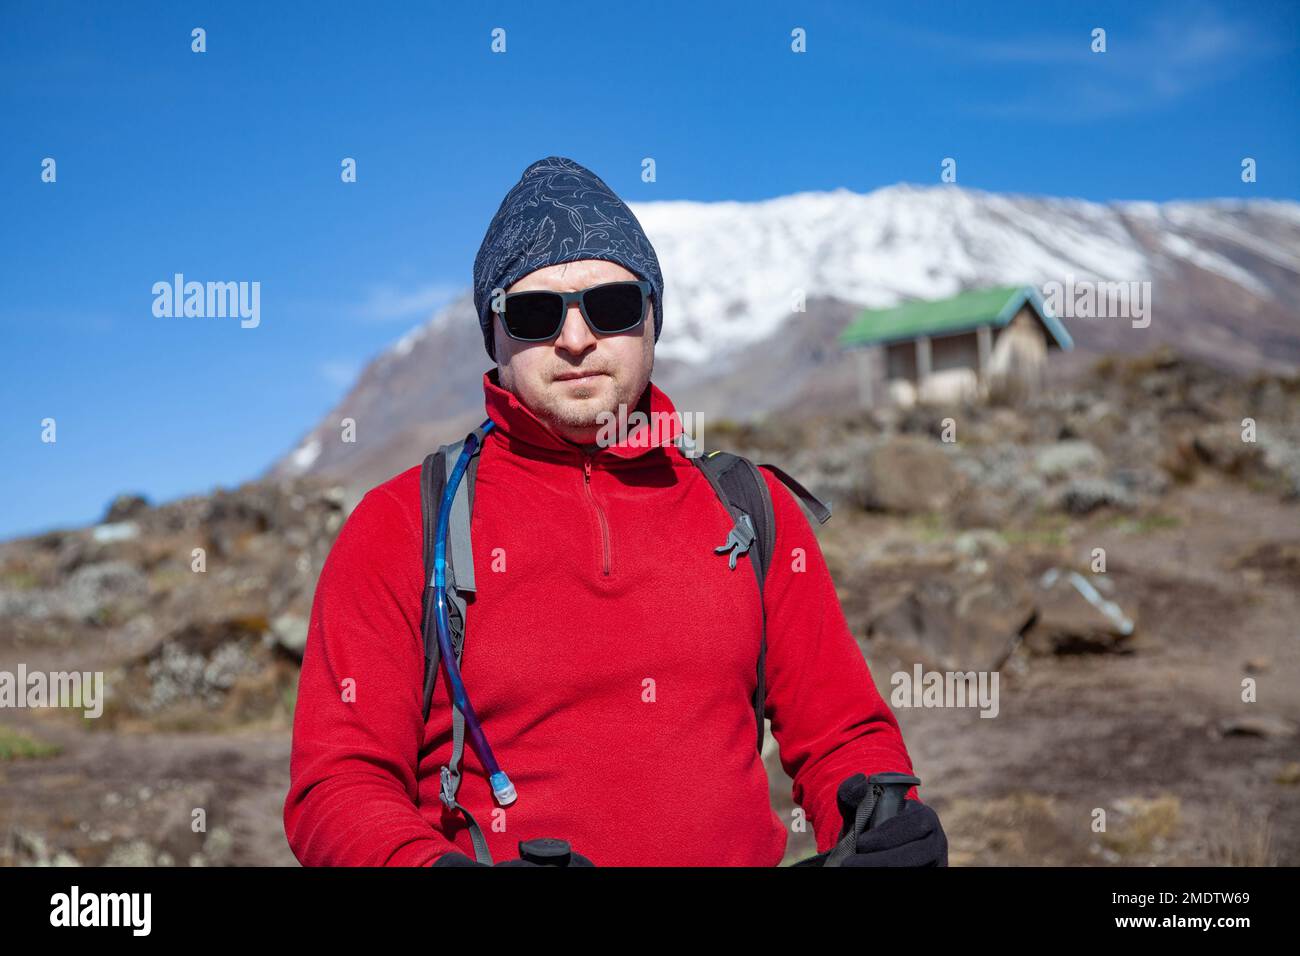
left=0, top=0, right=1300, bottom=538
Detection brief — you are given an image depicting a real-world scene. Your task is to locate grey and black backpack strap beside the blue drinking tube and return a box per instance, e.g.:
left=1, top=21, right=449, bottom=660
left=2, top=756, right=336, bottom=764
left=420, top=429, right=491, bottom=865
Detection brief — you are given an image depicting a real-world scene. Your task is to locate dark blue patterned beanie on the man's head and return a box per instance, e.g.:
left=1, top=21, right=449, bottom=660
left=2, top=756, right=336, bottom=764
left=475, top=156, right=663, bottom=362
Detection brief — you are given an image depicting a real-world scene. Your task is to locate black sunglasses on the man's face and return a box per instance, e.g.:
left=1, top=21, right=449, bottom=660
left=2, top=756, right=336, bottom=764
left=499, top=280, right=651, bottom=342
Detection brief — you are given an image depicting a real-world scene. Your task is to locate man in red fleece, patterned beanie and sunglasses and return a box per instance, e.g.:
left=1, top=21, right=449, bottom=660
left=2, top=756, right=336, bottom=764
left=285, top=156, right=946, bottom=866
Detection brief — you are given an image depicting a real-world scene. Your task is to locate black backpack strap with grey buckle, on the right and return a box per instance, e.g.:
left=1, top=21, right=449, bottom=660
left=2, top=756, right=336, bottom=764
left=688, top=451, right=831, bottom=754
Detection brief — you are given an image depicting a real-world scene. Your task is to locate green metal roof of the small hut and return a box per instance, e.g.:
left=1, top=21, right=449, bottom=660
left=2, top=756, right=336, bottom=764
left=840, top=285, right=1074, bottom=349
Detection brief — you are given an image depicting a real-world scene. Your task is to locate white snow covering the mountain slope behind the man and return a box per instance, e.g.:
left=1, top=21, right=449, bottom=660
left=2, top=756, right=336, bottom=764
left=633, top=185, right=1300, bottom=362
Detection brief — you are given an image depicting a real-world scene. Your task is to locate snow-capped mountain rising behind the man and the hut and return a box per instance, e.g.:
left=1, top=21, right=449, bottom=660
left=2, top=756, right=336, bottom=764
left=272, top=185, right=1300, bottom=486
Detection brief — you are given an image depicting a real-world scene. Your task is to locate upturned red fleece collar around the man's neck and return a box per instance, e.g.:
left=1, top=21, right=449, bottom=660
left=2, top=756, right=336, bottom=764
left=484, top=368, right=683, bottom=459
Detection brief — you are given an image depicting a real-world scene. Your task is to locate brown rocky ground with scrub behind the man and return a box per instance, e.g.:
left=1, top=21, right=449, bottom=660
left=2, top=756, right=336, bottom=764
left=0, top=354, right=1300, bottom=865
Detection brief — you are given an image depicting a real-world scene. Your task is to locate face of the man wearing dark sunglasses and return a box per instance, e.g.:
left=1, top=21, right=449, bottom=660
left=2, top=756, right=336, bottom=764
left=493, top=259, right=655, bottom=445
